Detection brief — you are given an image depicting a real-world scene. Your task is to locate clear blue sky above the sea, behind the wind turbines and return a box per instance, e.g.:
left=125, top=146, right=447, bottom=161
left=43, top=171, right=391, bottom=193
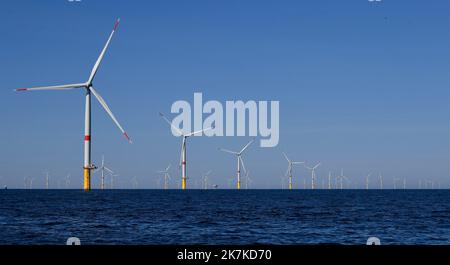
left=0, top=0, right=450, bottom=188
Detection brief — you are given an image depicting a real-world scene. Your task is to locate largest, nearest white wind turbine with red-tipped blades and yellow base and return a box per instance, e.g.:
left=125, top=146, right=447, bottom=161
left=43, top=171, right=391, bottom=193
left=16, top=19, right=131, bottom=191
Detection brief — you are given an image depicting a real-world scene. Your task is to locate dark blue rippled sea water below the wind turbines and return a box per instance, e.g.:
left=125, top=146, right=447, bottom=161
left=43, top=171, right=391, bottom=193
left=0, top=190, right=450, bottom=245
